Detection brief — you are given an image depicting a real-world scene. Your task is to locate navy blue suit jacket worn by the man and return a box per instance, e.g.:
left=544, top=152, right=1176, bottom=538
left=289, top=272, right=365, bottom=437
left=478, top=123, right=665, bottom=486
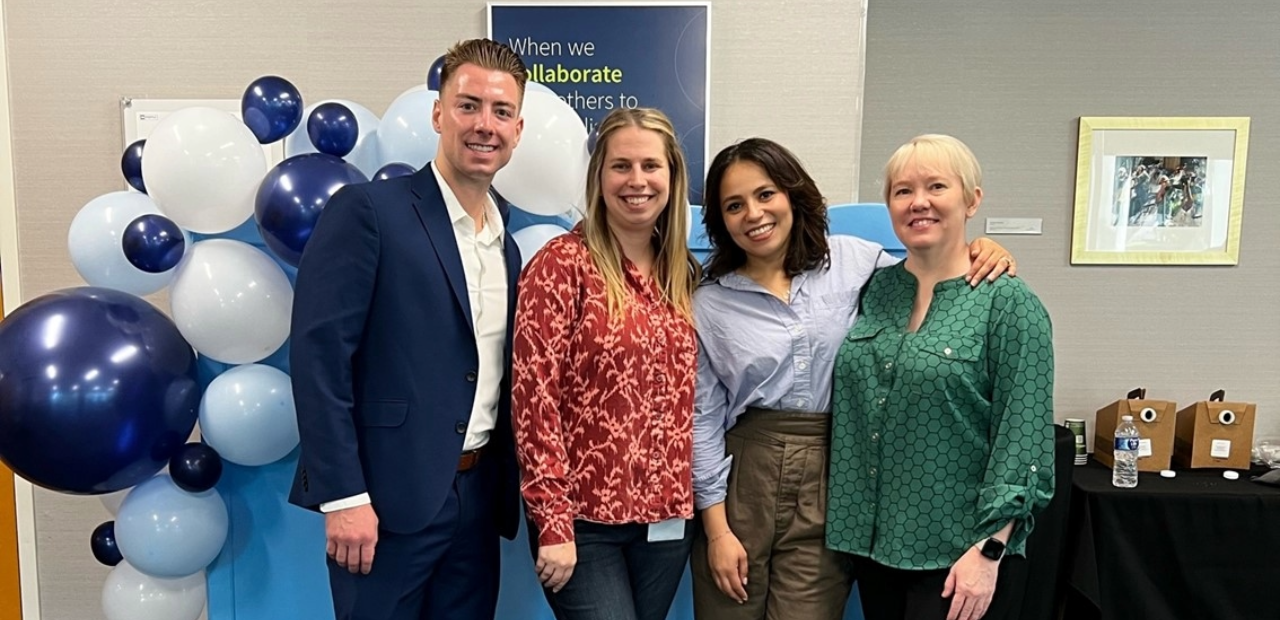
left=289, top=168, right=521, bottom=538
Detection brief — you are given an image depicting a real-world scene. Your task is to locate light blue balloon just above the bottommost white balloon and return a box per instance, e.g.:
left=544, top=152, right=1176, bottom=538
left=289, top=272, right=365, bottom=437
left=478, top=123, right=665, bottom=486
left=115, top=474, right=228, bottom=579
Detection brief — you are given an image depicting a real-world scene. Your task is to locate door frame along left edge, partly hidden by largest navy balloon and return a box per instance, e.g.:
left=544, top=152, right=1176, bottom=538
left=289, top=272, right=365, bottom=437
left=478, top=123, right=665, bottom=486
left=0, top=0, right=40, bottom=620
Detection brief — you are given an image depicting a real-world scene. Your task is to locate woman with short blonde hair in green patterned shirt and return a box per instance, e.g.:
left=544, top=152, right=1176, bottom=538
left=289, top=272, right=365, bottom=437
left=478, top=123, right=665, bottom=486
left=827, top=136, right=1053, bottom=620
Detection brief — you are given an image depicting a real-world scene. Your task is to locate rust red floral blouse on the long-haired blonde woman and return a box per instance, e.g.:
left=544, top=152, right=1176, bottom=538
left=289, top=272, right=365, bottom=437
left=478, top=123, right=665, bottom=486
left=512, top=229, right=698, bottom=546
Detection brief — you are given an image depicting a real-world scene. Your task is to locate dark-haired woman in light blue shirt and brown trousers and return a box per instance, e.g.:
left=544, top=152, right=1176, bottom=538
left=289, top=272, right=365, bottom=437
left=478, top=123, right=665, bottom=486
left=692, top=138, right=1012, bottom=620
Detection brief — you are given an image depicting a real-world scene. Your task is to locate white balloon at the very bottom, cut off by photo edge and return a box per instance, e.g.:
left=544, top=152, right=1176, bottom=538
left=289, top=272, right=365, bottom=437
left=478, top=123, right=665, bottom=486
left=102, top=561, right=209, bottom=620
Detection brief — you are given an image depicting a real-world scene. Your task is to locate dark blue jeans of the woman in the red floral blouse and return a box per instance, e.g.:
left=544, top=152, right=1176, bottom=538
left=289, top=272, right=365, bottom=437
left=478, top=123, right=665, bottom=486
left=529, top=520, right=694, bottom=620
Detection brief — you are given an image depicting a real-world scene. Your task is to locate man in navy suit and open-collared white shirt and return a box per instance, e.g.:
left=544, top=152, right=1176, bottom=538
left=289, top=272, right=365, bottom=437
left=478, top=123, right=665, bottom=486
left=289, top=40, right=527, bottom=620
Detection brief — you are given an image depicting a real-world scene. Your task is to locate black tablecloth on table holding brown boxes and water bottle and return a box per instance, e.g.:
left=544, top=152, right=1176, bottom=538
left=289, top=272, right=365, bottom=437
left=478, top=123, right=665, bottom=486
left=1071, top=459, right=1280, bottom=620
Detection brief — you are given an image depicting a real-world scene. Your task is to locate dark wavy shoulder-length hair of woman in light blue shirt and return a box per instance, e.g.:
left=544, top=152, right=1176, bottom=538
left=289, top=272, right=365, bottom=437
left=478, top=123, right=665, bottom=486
left=703, top=138, right=831, bottom=279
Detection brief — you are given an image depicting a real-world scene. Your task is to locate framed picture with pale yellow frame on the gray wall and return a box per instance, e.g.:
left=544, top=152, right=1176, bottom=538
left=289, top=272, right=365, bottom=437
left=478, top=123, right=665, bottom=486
left=1071, top=117, right=1249, bottom=265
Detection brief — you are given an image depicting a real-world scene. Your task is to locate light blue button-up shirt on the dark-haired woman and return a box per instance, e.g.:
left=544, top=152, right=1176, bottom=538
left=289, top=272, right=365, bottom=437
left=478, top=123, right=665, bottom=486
left=694, top=234, right=899, bottom=509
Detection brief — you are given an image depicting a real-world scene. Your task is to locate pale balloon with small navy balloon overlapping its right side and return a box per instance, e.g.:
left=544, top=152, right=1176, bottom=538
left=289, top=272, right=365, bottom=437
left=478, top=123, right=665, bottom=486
left=67, top=191, right=191, bottom=295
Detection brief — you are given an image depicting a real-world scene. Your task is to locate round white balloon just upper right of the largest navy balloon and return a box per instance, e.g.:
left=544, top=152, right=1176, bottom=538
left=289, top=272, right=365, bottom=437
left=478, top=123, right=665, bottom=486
left=169, top=240, right=293, bottom=364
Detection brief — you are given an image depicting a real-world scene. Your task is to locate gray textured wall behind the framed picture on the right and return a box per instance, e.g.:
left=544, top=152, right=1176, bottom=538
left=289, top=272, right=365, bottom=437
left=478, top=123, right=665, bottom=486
left=859, top=0, right=1280, bottom=437
